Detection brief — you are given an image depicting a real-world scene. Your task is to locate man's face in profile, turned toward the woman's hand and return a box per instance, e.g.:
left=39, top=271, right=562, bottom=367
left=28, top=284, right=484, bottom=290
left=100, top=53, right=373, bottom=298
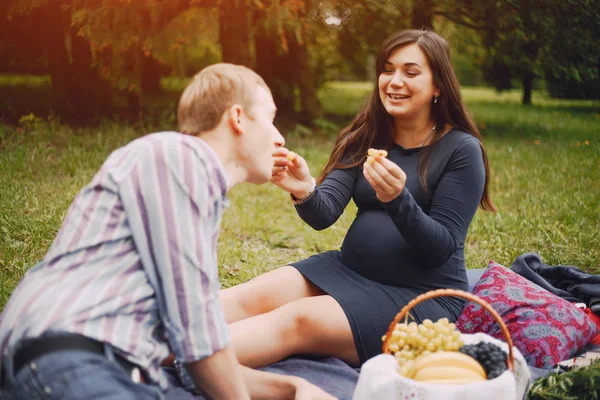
left=241, top=86, right=285, bottom=184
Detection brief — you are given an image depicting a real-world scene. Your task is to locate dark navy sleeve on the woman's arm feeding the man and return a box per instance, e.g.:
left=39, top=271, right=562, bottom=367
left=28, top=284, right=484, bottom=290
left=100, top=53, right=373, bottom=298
left=296, top=168, right=357, bottom=231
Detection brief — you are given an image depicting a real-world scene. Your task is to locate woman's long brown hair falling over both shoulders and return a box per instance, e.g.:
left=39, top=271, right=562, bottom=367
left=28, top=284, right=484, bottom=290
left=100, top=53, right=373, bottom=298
left=317, top=30, right=496, bottom=211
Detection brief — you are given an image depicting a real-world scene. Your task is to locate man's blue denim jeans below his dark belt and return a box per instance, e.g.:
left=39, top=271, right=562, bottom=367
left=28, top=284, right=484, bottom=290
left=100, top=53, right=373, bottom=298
left=0, top=350, right=164, bottom=400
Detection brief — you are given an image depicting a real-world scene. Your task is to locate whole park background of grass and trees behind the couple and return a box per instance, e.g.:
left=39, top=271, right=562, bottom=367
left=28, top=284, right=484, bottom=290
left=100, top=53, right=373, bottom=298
left=0, top=0, right=600, bottom=309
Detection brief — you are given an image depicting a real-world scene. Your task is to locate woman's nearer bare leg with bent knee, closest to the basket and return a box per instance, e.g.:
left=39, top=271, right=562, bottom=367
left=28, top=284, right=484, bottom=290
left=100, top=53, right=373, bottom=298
left=229, top=294, right=359, bottom=368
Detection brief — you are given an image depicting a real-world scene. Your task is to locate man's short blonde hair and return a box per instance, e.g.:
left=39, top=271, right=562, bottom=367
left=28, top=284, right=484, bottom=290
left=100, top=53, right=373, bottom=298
left=177, top=63, right=270, bottom=135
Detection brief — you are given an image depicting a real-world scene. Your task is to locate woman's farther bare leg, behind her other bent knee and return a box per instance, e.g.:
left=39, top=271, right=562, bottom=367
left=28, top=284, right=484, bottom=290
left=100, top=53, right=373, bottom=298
left=220, top=266, right=324, bottom=324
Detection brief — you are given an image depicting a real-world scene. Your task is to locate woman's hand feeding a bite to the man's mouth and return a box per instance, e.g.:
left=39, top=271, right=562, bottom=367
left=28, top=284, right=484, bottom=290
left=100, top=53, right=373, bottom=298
left=271, top=147, right=315, bottom=199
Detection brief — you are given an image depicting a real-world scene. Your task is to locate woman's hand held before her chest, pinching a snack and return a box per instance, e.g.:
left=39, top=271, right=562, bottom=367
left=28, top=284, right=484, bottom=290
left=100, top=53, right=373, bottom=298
left=363, top=155, right=406, bottom=203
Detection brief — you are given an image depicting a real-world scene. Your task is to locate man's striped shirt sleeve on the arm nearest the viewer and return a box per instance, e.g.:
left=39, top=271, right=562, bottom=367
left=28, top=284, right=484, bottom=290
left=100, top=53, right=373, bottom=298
left=120, top=140, right=229, bottom=363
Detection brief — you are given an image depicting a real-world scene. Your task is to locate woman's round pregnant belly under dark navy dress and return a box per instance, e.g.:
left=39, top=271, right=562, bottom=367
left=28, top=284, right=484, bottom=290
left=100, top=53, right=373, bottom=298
left=341, top=210, right=421, bottom=286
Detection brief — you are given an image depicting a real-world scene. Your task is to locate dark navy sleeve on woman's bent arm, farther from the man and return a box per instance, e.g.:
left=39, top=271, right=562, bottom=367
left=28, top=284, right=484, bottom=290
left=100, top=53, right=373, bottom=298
left=384, top=137, right=485, bottom=268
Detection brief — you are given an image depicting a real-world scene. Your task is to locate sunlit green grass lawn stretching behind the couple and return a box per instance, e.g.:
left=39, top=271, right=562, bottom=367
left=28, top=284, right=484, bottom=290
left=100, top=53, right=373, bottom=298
left=0, top=79, right=600, bottom=308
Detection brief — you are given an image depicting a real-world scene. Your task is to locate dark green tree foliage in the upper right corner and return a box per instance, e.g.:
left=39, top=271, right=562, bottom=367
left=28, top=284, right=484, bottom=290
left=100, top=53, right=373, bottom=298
left=435, top=0, right=600, bottom=104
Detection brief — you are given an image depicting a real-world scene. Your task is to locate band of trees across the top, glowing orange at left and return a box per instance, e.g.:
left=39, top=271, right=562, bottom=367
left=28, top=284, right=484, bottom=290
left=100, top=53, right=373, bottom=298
left=0, top=0, right=600, bottom=122
